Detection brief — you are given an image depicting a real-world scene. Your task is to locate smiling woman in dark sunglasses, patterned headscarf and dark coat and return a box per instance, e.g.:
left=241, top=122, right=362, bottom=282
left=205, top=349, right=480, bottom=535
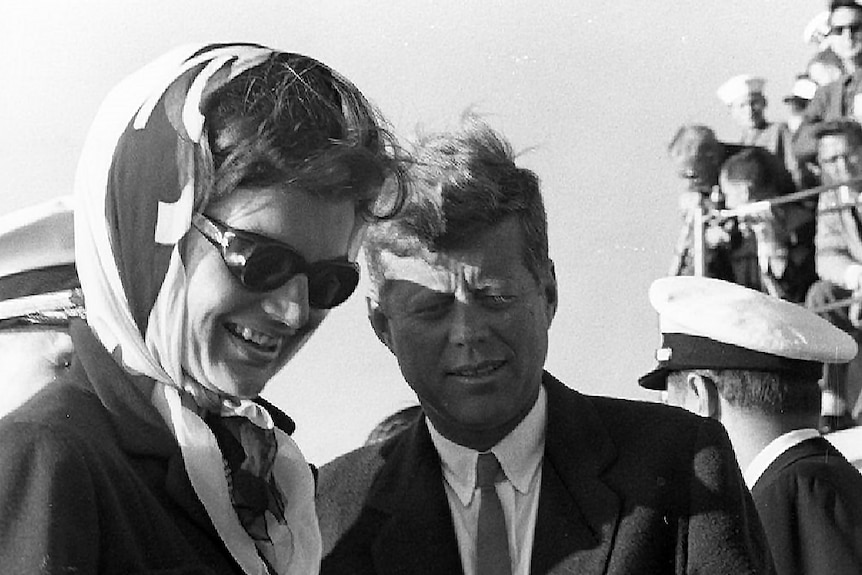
left=0, top=44, right=401, bottom=575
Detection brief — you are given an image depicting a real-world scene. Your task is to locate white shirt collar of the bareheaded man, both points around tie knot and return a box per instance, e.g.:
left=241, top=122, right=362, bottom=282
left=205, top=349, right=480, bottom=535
left=425, top=387, right=548, bottom=506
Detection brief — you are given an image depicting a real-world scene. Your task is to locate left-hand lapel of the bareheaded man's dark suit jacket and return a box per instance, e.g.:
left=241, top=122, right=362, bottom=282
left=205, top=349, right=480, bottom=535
left=368, top=419, right=462, bottom=575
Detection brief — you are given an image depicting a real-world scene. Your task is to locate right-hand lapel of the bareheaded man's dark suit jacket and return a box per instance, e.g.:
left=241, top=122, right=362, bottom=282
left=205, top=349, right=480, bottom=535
left=531, top=373, right=620, bottom=575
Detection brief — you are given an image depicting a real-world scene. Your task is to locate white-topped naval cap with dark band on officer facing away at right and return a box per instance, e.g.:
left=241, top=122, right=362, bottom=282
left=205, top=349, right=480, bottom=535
left=638, top=276, right=857, bottom=390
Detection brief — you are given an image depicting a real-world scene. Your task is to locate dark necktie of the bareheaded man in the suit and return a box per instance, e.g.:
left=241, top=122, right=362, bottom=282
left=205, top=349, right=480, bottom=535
left=476, top=452, right=512, bottom=575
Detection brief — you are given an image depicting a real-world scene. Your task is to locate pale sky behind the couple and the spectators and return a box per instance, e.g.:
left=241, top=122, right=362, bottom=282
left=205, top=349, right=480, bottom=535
left=0, top=0, right=825, bottom=464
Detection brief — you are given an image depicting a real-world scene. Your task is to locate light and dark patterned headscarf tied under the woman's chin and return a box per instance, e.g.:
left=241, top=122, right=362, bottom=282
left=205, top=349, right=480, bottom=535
left=75, top=44, right=321, bottom=575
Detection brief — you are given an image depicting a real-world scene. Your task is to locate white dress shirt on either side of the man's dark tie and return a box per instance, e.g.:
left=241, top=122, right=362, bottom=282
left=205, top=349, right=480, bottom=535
left=425, top=387, right=548, bottom=575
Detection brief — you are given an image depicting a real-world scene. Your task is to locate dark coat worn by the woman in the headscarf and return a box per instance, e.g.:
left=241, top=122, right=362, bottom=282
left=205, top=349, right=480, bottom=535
left=0, top=322, right=293, bottom=575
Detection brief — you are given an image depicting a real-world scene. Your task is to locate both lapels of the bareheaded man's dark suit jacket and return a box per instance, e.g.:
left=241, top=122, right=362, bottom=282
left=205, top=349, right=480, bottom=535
left=368, top=374, right=620, bottom=575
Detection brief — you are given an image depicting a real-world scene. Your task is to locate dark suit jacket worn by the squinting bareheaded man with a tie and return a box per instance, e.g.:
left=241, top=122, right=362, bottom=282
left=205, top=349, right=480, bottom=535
left=318, top=374, right=772, bottom=575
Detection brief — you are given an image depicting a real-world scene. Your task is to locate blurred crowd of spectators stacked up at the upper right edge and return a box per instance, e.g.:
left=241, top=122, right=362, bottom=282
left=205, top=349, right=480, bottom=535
left=668, top=0, right=862, bottom=432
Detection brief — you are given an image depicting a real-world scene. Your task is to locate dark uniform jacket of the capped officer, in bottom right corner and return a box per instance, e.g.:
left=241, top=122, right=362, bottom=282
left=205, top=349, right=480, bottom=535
left=751, top=437, right=862, bottom=575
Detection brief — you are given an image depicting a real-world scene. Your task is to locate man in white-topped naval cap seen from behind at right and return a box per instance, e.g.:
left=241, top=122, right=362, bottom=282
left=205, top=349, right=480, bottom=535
left=640, top=277, right=862, bottom=575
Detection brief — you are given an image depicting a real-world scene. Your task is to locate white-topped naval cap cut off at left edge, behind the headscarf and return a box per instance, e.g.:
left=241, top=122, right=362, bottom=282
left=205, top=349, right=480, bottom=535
left=0, top=196, right=83, bottom=327
